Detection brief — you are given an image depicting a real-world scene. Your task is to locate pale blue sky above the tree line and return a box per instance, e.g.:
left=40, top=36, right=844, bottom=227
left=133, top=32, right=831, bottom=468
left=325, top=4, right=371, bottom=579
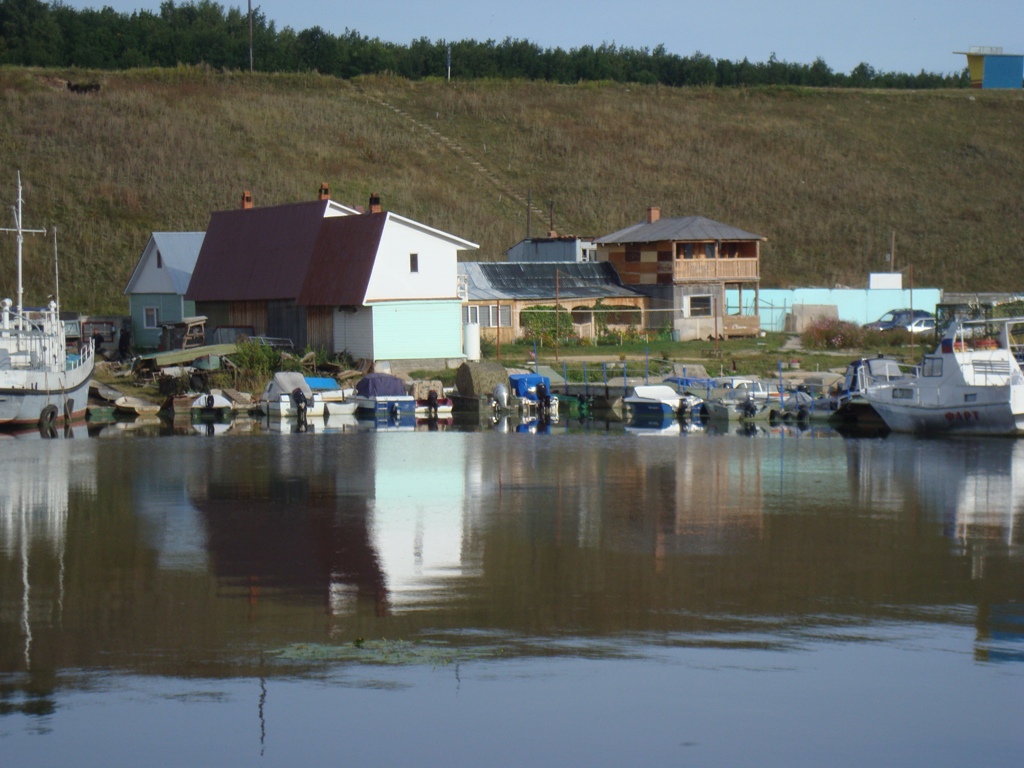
left=56, top=0, right=1024, bottom=74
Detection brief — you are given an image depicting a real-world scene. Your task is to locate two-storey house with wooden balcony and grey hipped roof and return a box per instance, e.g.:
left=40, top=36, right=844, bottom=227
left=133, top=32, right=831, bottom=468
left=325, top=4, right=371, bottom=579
left=595, top=207, right=766, bottom=341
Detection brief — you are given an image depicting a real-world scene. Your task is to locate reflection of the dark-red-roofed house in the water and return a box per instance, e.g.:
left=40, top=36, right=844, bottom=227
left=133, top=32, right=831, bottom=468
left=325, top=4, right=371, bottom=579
left=190, top=434, right=479, bottom=614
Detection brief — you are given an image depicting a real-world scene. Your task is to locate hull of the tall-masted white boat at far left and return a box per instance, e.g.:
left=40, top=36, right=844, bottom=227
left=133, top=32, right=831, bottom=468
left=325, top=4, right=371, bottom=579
left=0, top=358, right=93, bottom=427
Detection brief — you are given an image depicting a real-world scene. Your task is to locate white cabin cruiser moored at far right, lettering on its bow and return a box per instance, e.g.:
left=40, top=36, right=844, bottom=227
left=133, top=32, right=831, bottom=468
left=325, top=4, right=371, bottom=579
left=865, top=317, right=1024, bottom=435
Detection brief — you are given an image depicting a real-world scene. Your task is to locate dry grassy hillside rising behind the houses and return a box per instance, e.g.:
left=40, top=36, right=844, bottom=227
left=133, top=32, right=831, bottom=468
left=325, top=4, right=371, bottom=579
left=0, top=68, right=1024, bottom=312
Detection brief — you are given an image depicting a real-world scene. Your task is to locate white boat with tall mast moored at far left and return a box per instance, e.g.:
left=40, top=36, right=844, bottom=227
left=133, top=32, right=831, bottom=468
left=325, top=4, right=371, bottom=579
left=0, top=174, right=95, bottom=427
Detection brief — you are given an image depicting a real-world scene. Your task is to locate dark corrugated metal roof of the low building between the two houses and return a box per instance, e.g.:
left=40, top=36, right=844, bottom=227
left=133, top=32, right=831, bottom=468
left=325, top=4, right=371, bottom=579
left=459, top=261, right=642, bottom=301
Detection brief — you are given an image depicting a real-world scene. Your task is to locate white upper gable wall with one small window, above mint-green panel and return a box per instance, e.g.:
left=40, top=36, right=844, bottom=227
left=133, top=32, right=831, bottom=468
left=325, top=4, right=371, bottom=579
left=366, top=214, right=460, bottom=303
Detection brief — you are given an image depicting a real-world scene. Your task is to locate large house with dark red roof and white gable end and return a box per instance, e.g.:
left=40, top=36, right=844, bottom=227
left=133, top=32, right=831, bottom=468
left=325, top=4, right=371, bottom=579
left=186, top=186, right=477, bottom=360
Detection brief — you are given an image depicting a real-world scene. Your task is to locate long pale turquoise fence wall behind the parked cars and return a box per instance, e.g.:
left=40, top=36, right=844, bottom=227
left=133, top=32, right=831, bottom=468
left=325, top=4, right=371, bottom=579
left=725, top=288, right=942, bottom=331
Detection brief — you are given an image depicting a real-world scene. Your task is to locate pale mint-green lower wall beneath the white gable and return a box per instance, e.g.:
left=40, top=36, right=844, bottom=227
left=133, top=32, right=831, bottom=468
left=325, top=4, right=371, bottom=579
left=374, top=299, right=463, bottom=360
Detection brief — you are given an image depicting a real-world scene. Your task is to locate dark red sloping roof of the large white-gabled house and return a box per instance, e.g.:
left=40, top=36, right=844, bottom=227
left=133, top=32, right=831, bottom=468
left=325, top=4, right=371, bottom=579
left=186, top=200, right=388, bottom=306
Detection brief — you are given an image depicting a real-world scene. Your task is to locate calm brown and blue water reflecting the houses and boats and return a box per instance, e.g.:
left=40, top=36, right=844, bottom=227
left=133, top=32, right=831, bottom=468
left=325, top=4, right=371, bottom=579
left=0, top=424, right=1024, bottom=766
